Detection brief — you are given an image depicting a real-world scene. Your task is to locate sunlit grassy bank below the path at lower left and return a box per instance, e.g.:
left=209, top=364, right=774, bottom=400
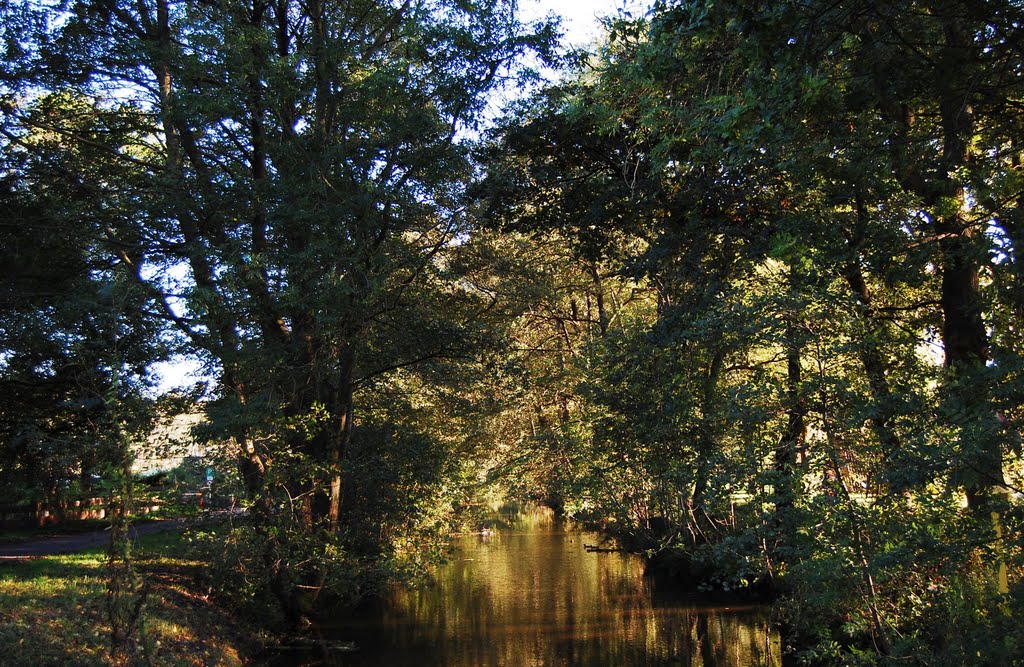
left=0, top=532, right=262, bottom=666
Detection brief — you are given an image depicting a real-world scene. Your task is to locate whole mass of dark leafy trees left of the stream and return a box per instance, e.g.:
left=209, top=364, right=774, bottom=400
left=0, top=0, right=553, bottom=621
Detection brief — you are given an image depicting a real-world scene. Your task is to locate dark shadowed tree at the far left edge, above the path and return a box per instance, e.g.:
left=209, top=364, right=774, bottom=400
left=0, top=93, right=165, bottom=502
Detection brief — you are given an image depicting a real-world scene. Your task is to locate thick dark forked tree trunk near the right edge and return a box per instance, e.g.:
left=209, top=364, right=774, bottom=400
left=862, top=11, right=1006, bottom=590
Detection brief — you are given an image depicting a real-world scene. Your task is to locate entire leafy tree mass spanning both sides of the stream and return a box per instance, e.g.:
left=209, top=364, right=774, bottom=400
left=0, top=0, right=1024, bottom=665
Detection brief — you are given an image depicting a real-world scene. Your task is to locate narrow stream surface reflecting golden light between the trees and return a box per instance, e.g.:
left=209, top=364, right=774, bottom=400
left=292, top=508, right=780, bottom=667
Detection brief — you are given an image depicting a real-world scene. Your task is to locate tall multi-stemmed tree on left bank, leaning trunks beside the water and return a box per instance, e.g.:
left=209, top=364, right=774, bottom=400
left=4, top=0, right=553, bottom=618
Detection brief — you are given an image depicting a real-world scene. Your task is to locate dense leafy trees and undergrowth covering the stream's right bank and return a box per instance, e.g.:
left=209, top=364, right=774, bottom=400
left=479, top=1, right=1024, bottom=665
